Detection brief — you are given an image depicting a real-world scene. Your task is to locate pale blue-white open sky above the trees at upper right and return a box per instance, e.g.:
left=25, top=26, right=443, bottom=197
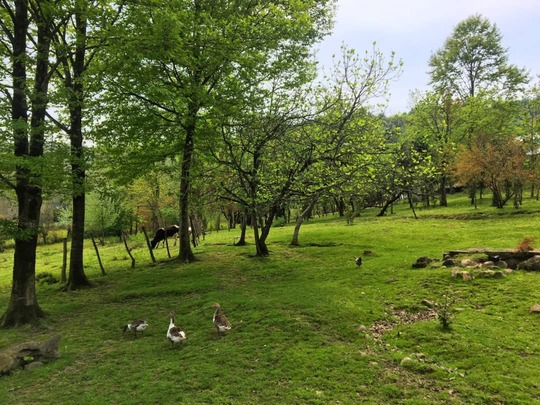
left=317, top=0, right=540, bottom=115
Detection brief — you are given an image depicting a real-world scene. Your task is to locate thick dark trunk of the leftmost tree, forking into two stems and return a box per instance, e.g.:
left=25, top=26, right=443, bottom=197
left=2, top=0, right=46, bottom=327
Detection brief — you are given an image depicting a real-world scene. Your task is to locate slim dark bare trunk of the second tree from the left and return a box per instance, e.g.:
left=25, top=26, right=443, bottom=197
left=65, top=10, right=90, bottom=291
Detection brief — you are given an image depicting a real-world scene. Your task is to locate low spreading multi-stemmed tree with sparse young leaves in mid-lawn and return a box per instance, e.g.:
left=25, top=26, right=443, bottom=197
left=214, top=47, right=400, bottom=252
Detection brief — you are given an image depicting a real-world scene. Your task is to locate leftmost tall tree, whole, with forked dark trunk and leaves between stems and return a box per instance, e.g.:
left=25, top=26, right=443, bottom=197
left=0, top=0, right=52, bottom=327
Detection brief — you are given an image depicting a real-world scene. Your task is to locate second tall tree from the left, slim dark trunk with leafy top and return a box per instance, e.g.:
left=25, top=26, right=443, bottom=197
left=50, top=0, right=122, bottom=290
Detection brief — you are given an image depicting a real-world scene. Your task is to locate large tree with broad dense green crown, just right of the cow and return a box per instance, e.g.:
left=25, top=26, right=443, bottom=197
left=97, top=0, right=335, bottom=262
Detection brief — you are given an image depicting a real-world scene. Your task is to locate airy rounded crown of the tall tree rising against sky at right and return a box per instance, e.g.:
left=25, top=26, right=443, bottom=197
left=429, top=14, right=527, bottom=100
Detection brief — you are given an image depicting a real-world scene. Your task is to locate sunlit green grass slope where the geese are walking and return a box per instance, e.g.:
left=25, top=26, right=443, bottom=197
left=0, top=196, right=540, bottom=404
